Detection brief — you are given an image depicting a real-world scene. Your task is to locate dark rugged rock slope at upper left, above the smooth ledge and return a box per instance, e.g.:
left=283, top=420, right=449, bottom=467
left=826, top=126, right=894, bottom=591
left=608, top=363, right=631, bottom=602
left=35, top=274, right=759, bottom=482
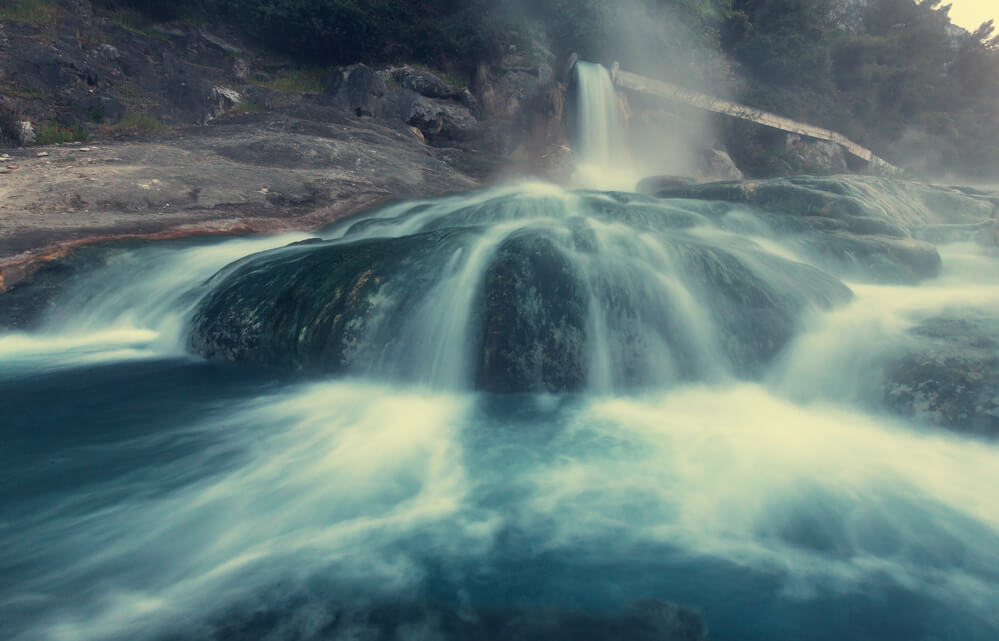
left=0, top=13, right=246, bottom=127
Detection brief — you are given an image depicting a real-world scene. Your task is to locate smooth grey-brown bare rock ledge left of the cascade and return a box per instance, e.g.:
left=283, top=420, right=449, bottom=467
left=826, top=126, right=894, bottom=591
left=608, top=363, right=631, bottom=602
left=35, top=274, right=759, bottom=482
left=0, top=104, right=481, bottom=288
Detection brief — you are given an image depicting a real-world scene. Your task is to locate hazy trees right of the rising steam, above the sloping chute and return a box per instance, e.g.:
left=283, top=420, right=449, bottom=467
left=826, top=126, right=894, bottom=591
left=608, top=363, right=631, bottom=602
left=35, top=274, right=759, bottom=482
left=722, top=0, right=999, bottom=177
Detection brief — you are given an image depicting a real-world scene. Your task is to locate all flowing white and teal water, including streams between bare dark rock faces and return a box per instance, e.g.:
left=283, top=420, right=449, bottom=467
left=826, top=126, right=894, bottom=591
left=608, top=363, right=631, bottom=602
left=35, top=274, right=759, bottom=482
left=0, top=63, right=999, bottom=641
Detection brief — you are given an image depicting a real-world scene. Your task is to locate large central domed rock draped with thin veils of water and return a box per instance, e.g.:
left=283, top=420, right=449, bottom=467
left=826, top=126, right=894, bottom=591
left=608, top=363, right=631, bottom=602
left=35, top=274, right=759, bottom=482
left=191, top=190, right=852, bottom=392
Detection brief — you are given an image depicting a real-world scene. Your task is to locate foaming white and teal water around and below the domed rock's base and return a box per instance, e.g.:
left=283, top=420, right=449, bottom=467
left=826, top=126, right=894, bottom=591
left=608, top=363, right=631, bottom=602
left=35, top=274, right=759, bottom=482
left=0, top=182, right=999, bottom=640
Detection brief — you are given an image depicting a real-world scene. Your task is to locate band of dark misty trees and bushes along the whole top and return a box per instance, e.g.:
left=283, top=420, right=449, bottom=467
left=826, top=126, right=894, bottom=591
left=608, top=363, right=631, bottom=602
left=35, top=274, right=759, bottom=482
left=50, top=0, right=999, bottom=177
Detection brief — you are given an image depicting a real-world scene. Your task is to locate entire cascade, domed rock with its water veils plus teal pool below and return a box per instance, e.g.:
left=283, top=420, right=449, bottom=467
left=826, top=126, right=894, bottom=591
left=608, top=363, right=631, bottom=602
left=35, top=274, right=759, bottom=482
left=0, top=171, right=999, bottom=641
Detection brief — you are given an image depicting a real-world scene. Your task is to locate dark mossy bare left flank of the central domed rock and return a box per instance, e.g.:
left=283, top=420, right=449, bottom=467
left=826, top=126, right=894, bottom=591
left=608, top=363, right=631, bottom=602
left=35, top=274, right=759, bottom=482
left=191, top=232, right=468, bottom=373
